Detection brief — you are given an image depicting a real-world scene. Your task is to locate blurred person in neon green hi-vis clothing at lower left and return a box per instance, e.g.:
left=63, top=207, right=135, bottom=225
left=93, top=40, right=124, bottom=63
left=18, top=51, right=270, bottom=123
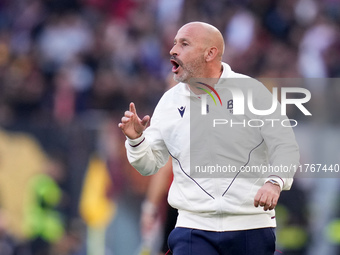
left=24, top=155, right=65, bottom=255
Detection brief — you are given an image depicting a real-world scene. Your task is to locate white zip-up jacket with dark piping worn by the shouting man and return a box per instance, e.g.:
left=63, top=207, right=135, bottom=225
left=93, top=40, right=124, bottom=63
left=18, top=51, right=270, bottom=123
left=126, top=63, right=299, bottom=231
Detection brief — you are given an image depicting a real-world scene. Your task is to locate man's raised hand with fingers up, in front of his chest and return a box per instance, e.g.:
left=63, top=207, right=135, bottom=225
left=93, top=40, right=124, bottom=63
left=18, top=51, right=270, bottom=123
left=118, top=103, right=150, bottom=139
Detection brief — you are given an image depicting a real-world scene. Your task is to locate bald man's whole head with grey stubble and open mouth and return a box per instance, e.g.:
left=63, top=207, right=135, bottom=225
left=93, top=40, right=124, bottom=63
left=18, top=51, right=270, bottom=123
left=170, top=22, right=224, bottom=82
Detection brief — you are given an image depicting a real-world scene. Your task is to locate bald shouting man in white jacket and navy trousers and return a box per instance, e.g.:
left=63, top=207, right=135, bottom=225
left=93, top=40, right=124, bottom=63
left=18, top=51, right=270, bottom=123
left=118, top=22, right=299, bottom=255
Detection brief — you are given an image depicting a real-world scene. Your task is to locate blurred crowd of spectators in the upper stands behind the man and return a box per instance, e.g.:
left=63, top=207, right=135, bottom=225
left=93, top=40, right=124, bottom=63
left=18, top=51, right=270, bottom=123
left=0, top=0, right=340, bottom=125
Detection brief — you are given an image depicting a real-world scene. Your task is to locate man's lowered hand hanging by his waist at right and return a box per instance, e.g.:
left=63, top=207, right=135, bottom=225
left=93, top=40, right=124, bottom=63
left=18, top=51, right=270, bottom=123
left=254, top=182, right=281, bottom=211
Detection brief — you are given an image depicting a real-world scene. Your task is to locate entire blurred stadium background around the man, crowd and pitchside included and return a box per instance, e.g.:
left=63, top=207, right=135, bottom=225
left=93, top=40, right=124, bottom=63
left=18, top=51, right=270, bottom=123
left=0, top=0, right=340, bottom=255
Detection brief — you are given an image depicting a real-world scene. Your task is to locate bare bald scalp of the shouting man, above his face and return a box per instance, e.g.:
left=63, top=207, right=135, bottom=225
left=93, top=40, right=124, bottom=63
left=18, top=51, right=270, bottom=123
left=178, top=21, right=224, bottom=60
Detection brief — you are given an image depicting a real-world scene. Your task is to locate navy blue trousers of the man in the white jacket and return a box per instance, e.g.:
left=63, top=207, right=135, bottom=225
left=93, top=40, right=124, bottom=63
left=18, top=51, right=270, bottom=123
left=168, top=227, right=276, bottom=255
